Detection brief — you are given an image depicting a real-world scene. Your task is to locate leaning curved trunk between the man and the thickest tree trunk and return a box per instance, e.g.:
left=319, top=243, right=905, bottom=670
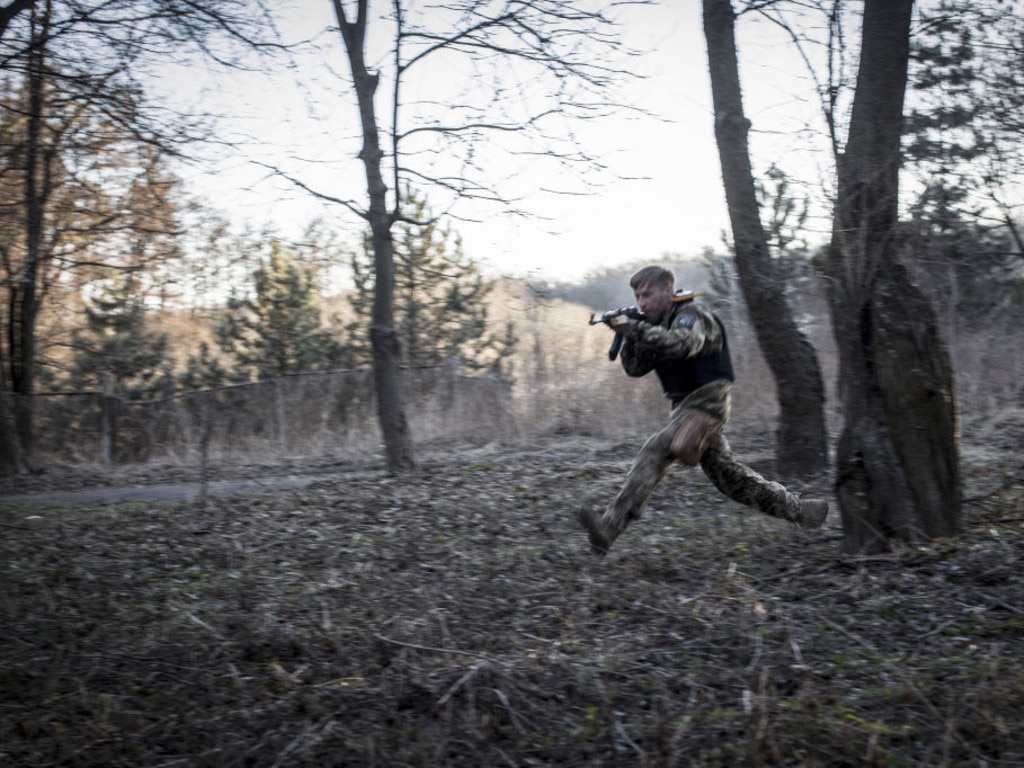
left=703, top=0, right=828, bottom=475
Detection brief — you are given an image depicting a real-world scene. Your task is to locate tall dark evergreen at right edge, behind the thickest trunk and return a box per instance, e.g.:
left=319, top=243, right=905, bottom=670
left=903, top=0, right=1024, bottom=323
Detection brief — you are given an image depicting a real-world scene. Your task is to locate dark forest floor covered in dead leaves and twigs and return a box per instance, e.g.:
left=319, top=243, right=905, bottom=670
left=0, top=419, right=1024, bottom=768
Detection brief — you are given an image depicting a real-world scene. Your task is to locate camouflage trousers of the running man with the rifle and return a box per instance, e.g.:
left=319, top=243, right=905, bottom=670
left=602, top=380, right=800, bottom=536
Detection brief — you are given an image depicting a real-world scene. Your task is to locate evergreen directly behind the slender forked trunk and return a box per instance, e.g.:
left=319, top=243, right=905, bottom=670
left=350, top=188, right=516, bottom=376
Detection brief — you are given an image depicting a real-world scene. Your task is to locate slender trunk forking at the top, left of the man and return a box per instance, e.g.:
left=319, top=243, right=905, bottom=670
left=334, top=0, right=413, bottom=472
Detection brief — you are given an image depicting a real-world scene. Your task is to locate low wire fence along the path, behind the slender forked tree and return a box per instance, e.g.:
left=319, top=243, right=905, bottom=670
left=17, top=365, right=515, bottom=464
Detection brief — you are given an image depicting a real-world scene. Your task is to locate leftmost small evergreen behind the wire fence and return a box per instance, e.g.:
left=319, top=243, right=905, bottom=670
left=72, top=272, right=171, bottom=396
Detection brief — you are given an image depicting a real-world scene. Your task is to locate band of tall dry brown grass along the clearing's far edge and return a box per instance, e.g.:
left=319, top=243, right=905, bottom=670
left=18, top=281, right=1024, bottom=467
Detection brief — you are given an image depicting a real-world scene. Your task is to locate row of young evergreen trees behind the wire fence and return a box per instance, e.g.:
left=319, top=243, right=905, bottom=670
left=54, top=191, right=515, bottom=398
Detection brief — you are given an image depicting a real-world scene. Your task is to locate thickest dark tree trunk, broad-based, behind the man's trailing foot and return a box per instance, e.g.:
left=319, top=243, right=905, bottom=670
left=829, top=0, right=961, bottom=553
